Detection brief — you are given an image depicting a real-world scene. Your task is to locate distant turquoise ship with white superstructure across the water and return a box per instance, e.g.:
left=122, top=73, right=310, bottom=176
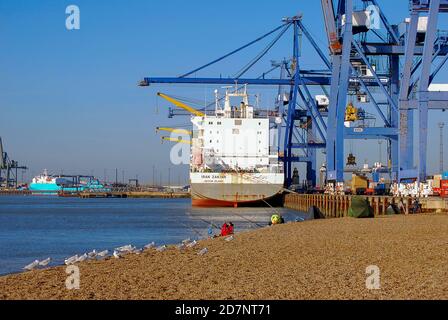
left=29, top=170, right=110, bottom=194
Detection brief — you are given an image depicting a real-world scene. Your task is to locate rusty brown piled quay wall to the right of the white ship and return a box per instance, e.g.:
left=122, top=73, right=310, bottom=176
left=284, top=194, right=448, bottom=218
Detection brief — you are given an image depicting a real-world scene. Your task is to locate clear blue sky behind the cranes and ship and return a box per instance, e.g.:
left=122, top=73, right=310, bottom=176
left=0, top=0, right=448, bottom=184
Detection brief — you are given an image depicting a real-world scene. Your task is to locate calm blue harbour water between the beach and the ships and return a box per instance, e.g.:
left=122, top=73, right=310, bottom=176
left=0, top=196, right=306, bottom=274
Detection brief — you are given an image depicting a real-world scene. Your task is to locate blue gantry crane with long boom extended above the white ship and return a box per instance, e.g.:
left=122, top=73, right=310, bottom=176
left=140, top=15, right=331, bottom=185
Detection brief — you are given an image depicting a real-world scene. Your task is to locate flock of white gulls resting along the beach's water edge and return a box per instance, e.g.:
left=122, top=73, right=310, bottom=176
left=23, top=236, right=224, bottom=271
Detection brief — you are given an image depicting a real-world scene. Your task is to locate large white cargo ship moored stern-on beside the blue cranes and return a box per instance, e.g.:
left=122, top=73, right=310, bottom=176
left=190, top=86, right=284, bottom=207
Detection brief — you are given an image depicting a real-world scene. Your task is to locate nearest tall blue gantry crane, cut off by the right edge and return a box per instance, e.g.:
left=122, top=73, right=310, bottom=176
left=326, top=0, right=448, bottom=182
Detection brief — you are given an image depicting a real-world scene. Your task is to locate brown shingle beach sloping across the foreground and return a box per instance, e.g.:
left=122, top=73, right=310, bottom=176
left=0, top=215, right=448, bottom=300
